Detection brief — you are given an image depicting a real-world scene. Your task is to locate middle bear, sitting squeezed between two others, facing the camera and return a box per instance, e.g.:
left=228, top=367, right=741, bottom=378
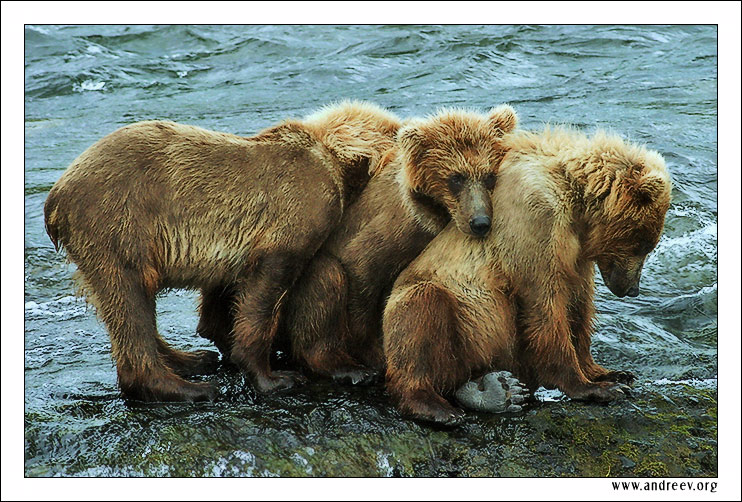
left=282, top=105, right=517, bottom=383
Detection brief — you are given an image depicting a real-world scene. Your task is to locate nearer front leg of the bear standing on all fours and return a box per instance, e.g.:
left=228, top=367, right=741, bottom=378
left=231, top=254, right=306, bottom=393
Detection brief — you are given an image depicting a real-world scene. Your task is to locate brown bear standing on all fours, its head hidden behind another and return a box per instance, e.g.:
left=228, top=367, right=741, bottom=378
left=44, top=102, right=401, bottom=401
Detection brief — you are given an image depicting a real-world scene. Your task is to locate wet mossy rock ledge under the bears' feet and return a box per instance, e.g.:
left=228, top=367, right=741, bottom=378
left=25, top=375, right=718, bottom=477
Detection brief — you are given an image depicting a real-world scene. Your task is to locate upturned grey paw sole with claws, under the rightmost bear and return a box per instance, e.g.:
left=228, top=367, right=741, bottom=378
left=456, top=371, right=528, bottom=413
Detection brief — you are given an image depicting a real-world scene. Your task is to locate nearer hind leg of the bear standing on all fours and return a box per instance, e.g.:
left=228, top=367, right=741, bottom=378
left=80, top=267, right=217, bottom=401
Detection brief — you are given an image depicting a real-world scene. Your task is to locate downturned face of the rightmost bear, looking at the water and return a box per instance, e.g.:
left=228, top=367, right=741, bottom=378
left=586, top=139, right=671, bottom=297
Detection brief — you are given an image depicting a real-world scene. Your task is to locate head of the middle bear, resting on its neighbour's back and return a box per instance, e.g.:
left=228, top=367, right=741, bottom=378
left=397, top=105, right=518, bottom=237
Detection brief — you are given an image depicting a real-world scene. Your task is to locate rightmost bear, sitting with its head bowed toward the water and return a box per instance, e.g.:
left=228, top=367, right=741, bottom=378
left=383, top=128, right=671, bottom=423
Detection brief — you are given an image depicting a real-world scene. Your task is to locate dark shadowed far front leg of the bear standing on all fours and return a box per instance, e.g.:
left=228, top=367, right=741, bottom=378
left=196, top=286, right=235, bottom=361
